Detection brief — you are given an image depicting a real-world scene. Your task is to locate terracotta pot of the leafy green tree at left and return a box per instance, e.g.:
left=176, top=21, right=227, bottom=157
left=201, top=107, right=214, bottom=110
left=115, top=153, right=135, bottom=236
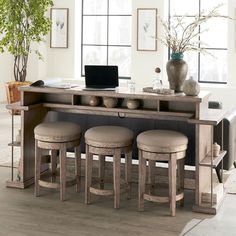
left=5, top=81, right=31, bottom=115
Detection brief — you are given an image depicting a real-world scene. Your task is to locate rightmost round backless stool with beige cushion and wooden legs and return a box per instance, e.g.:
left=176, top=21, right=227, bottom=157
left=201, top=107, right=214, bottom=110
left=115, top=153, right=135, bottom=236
left=137, top=130, right=188, bottom=216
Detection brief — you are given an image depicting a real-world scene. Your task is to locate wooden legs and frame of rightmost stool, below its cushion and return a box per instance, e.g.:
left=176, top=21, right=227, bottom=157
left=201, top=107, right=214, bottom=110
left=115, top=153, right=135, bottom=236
left=138, top=144, right=185, bottom=216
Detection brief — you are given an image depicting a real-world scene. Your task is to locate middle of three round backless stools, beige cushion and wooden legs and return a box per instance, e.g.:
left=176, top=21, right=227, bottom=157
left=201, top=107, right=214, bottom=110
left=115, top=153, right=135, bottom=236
left=85, top=126, right=134, bottom=208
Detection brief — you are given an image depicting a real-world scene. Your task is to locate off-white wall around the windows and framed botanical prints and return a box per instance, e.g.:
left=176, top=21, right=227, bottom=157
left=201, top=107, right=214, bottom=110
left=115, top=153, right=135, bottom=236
left=0, top=0, right=236, bottom=108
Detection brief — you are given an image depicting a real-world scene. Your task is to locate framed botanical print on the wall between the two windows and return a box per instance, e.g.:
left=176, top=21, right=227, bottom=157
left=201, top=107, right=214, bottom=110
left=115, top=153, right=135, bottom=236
left=137, top=8, right=158, bottom=51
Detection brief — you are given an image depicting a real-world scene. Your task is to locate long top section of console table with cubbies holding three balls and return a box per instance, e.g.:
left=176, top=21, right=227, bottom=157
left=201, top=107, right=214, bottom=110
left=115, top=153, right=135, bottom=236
left=19, top=87, right=210, bottom=122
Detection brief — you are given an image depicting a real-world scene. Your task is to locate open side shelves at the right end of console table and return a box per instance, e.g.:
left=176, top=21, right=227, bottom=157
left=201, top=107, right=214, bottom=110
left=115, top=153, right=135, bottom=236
left=189, top=109, right=227, bottom=214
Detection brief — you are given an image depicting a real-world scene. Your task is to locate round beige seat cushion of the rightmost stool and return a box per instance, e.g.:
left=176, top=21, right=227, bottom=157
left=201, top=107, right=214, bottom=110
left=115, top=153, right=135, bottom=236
left=137, top=130, right=188, bottom=153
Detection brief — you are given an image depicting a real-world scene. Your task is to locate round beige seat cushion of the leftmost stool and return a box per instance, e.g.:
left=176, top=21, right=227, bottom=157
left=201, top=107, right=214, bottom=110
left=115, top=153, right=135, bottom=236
left=34, top=122, right=81, bottom=143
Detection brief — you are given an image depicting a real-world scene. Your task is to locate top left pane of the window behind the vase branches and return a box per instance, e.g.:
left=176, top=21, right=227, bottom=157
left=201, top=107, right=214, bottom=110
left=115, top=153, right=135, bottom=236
left=170, top=0, right=199, bottom=15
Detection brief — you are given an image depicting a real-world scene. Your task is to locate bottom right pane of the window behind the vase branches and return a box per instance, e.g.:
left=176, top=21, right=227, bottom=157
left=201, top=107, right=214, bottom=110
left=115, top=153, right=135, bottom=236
left=200, top=50, right=227, bottom=82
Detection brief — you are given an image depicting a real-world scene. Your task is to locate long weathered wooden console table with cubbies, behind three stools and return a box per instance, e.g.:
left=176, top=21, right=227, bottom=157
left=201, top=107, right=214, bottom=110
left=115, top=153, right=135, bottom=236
left=7, top=86, right=226, bottom=214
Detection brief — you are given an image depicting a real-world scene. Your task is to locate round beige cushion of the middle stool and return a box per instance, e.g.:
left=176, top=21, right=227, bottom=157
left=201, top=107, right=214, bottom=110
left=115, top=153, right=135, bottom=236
left=84, top=126, right=134, bottom=148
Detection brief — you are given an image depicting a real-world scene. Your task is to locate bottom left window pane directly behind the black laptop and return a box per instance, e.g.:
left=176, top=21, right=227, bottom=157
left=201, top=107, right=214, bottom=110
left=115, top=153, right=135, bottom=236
left=82, top=46, right=107, bottom=74
